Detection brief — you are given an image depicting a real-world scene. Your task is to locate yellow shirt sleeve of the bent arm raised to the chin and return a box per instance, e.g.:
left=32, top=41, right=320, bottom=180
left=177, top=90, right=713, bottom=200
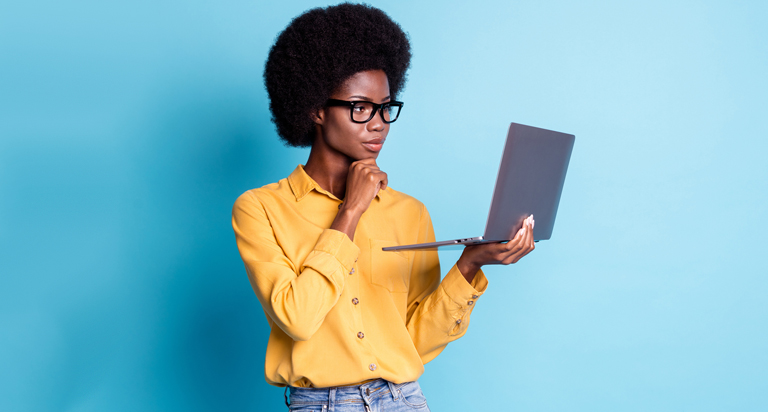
left=232, top=192, right=360, bottom=341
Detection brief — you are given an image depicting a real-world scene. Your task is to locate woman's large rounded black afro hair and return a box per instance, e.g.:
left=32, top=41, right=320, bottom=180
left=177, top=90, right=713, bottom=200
left=264, top=3, right=411, bottom=147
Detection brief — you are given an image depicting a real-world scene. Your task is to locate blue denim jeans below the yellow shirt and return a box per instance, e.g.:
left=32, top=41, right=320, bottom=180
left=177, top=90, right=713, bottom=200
left=288, top=379, right=429, bottom=412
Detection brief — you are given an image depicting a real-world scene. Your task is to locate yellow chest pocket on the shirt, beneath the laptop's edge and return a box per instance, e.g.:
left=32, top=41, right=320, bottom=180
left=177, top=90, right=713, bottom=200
left=369, top=239, right=410, bottom=292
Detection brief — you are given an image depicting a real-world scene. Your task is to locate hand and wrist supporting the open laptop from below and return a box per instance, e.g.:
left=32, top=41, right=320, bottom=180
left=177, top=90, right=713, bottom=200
left=456, top=215, right=536, bottom=282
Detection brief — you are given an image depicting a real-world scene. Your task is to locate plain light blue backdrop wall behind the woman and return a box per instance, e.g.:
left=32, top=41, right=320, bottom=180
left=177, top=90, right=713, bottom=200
left=0, top=0, right=768, bottom=411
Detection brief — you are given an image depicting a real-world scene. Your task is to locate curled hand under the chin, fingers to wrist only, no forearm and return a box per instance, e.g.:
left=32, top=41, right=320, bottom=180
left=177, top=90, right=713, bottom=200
left=341, top=158, right=387, bottom=215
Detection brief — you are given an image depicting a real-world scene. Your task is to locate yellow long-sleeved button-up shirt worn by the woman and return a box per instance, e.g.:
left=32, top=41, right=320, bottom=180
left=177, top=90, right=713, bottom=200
left=232, top=165, right=488, bottom=387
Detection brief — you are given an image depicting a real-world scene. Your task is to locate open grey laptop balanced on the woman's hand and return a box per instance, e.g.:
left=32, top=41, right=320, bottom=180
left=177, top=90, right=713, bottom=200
left=382, top=123, right=575, bottom=250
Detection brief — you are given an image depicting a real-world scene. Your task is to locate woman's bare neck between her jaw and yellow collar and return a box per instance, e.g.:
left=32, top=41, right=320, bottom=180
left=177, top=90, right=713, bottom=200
left=304, top=129, right=354, bottom=199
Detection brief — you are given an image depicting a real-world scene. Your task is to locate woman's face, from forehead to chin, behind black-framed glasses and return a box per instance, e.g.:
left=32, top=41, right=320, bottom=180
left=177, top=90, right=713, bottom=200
left=315, top=70, right=391, bottom=161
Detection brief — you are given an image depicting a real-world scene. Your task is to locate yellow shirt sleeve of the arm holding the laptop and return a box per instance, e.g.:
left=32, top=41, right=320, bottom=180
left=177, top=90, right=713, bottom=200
left=406, top=206, right=488, bottom=363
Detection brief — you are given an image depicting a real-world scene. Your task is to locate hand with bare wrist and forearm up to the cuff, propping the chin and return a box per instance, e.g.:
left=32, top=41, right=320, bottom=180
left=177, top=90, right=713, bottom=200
left=331, top=158, right=388, bottom=240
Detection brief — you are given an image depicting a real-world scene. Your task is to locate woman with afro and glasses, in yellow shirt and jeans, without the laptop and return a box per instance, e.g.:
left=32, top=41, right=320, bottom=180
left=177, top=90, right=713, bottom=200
left=233, top=4, right=534, bottom=411
